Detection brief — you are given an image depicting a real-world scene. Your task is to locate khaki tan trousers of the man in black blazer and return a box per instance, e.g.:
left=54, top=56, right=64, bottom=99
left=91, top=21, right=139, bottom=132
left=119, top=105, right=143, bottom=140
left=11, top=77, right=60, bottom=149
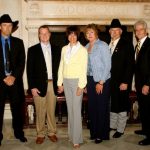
left=34, top=82, right=56, bottom=137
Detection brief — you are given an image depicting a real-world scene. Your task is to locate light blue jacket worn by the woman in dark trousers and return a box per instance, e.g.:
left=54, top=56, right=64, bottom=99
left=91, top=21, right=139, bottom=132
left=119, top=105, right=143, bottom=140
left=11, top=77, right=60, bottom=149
left=86, top=39, right=111, bottom=82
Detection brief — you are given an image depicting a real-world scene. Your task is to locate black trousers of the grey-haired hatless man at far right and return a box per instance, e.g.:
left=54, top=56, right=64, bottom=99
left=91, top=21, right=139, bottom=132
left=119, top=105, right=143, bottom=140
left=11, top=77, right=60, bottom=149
left=137, top=90, right=150, bottom=139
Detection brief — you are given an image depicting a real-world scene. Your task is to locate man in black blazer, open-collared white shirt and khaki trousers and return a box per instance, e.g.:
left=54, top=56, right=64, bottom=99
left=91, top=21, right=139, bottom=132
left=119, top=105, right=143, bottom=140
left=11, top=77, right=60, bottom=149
left=27, top=25, right=60, bottom=144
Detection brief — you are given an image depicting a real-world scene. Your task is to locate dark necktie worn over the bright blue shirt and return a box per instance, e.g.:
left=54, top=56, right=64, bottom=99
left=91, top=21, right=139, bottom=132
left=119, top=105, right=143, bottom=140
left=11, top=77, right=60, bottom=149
left=5, top=39, right=11, bottom=73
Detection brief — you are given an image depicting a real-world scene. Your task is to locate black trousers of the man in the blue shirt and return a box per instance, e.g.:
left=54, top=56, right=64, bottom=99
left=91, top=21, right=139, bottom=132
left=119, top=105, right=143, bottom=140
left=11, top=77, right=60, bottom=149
left=0, top=83, right=24, bottom=140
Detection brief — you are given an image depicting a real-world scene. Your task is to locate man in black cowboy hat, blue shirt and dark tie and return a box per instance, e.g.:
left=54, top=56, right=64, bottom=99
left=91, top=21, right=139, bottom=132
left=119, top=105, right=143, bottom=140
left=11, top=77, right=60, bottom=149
left=0, top=14, right=27, bottom=144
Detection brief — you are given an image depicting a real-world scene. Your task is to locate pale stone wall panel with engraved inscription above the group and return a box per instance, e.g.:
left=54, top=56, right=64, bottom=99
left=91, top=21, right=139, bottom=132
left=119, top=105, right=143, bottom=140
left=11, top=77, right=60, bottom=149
left=28, top=1, right=150, bottom=19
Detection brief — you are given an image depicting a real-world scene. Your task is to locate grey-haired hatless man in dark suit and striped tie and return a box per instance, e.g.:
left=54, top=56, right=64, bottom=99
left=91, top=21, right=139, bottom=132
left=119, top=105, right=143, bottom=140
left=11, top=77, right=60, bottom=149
left=134, top=20, right=150, bottom=145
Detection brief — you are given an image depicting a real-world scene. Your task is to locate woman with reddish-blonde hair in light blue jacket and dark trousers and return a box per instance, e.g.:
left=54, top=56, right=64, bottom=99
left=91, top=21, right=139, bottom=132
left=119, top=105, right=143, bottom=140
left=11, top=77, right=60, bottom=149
left=85, top=24, right=111, bottom=143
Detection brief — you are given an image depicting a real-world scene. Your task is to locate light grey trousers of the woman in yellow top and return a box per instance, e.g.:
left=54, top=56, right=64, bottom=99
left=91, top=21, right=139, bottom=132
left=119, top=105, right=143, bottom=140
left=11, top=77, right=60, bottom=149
left=63, top=79, right=83, bottom=144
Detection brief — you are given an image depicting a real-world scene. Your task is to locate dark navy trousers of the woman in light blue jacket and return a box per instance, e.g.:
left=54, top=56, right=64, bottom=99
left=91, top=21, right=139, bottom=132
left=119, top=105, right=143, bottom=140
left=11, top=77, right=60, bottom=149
left=87, top=76, right=110, bottom=140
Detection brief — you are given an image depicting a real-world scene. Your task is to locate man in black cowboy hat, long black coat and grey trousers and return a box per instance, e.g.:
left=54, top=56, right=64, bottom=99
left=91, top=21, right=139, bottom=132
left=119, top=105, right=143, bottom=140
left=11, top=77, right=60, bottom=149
left=109, top=19, right=134, bottom=138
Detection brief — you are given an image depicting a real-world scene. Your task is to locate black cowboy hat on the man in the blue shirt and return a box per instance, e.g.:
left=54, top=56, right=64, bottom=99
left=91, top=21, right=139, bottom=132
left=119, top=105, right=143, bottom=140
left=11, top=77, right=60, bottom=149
left=0, top=14, right=19, bottom=29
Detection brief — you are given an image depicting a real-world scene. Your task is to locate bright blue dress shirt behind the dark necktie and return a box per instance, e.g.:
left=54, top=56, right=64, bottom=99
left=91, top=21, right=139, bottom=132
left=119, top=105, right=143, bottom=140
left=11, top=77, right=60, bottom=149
left=1, top=36, right=10, bottom=75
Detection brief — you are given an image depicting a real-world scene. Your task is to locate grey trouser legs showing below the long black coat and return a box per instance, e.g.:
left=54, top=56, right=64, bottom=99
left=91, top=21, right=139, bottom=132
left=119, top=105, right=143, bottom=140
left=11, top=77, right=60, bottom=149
left=110, top=111, right=128, bottom=133
